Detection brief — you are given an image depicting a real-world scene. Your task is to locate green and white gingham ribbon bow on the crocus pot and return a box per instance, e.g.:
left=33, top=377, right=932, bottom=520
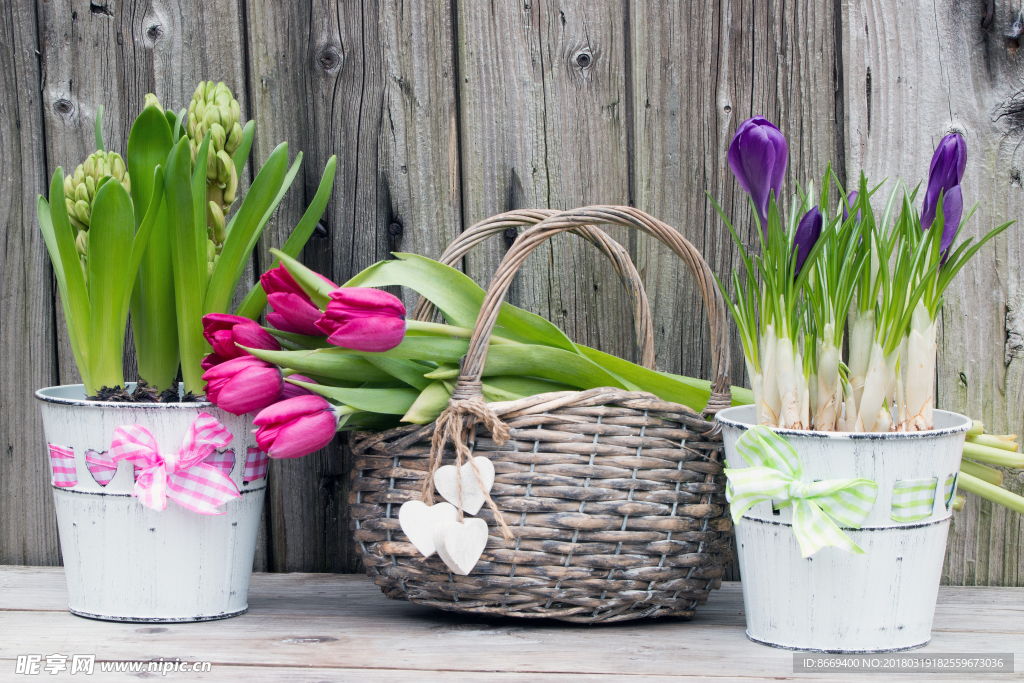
left=725, top=425, right=879, bottom=557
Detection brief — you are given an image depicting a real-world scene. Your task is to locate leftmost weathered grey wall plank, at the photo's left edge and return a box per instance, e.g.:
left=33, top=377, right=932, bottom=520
left=0, top=2, right=60, bottom=564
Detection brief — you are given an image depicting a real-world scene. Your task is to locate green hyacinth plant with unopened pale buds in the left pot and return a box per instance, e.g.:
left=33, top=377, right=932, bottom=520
left=37, top=82, right=336, bottom=401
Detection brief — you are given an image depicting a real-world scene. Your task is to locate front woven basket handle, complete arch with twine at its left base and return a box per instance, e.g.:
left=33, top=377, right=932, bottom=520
left=452, top=206, right=731, bottom=415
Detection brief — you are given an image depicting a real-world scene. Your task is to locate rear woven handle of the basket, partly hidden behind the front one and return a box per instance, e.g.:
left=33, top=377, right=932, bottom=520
left=413, top=209, right=654, bottom=370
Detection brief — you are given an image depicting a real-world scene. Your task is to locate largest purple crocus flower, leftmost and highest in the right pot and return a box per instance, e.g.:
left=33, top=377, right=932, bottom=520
left=729, top=116, right=788, bottom=236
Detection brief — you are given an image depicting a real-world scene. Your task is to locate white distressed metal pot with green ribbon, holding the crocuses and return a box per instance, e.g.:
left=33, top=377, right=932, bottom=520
left=718, top=405, right=971, bottom=652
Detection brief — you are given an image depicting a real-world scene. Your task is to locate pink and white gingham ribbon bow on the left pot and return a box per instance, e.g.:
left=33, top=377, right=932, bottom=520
left=110, top=413, right=241, bottom=515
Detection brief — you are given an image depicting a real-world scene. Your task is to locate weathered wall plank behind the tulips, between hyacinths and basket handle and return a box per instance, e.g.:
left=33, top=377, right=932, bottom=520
left=248, top=0, right=461, bottom=571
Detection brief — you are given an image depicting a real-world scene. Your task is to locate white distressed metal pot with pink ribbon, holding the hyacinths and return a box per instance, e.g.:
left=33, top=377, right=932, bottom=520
left=36, top=383, right=266, bottom=622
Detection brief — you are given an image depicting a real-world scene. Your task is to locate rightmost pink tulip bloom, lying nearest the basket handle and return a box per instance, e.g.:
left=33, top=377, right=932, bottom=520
left=316, top=287, right=406, bottom=351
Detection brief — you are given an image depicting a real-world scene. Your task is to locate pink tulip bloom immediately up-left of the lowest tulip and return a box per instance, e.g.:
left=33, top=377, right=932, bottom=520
left=203, top=355, right=284, bottom=415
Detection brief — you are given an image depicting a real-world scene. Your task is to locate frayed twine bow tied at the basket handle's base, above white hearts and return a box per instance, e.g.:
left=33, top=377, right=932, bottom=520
left=422, top=378, right=512, bottom=541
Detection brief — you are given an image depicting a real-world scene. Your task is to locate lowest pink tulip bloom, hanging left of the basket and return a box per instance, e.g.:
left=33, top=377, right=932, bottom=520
left=253, top=395, right=338, bottom=458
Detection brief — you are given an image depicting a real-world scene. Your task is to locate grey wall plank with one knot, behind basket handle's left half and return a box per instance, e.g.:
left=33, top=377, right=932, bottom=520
left=458, top=0, right=635, bottom=358
